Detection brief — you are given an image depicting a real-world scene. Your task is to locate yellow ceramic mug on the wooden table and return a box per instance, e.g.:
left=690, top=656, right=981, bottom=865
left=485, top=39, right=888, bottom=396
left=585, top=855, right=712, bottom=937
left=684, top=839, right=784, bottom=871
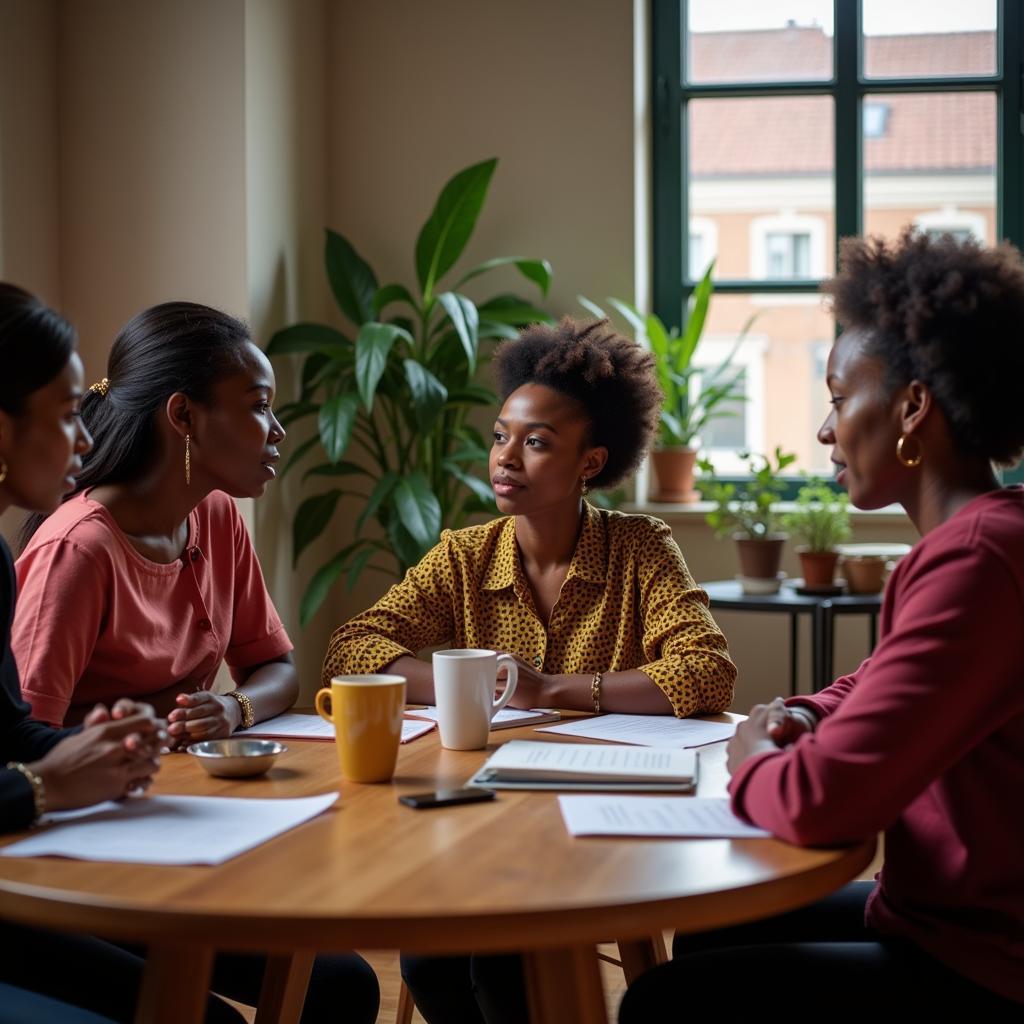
left=316, top=676, right=406, bottom=782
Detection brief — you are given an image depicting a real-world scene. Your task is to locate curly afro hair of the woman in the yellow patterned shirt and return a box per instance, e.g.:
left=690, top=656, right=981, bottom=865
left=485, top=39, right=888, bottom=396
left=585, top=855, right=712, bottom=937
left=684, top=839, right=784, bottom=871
left=495, top=316, right=664, bottom=487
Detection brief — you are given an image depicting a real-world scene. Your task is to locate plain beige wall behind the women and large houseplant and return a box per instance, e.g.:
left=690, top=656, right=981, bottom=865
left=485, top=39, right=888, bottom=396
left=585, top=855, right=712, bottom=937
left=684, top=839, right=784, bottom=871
left=0, top=0, right=906, bottom=708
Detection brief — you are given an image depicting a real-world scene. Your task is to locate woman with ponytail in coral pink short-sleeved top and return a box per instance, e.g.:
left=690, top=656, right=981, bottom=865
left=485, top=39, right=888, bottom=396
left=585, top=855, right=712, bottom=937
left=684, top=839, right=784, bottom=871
left=13, top=302, right=298, bottom=745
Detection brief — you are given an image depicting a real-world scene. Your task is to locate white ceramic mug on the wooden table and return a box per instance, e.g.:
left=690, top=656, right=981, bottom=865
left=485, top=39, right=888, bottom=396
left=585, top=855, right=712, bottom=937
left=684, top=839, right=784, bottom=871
left=434, top=649, right=519, bottom=751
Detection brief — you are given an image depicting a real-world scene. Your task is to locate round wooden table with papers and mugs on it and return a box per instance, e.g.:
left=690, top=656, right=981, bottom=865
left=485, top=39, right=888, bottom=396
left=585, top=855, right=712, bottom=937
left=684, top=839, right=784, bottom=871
left=0, top=729, right=874, bottom=1024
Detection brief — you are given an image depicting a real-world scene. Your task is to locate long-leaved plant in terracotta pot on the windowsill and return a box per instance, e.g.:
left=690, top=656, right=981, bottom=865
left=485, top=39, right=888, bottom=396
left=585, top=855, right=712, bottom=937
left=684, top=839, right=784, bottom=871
left=580, top=260, right=756, bottom=503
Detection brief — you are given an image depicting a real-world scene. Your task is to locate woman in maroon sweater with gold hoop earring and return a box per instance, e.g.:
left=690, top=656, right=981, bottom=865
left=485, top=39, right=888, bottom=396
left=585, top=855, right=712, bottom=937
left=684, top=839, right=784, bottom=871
left=620, top=231, right=1024, bottom=1024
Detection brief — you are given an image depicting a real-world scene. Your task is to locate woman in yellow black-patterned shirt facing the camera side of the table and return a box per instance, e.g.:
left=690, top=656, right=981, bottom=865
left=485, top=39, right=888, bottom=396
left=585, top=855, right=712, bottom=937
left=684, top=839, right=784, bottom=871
left=324, top=318, right=736, bottom=718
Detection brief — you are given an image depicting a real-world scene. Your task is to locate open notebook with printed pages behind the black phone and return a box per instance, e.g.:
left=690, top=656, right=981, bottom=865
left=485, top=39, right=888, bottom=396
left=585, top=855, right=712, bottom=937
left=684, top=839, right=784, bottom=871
left=469, top=739, right=697, bottom=793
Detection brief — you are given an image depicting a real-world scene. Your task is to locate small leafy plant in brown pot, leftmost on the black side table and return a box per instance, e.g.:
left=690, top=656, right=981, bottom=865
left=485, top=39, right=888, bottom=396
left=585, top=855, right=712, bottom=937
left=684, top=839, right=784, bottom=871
left=700, top=446, right=797, bottom=594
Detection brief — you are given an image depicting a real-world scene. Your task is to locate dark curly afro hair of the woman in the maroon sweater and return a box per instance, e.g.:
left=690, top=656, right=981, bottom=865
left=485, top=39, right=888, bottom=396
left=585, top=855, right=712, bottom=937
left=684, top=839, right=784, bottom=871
left=824, top=228, right=1024, bottom=465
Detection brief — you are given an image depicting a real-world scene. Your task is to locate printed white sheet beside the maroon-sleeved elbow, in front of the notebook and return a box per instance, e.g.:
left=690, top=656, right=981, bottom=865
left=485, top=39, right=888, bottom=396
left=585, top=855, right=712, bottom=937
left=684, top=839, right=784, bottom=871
left=558, top=796, right=771, bottom=839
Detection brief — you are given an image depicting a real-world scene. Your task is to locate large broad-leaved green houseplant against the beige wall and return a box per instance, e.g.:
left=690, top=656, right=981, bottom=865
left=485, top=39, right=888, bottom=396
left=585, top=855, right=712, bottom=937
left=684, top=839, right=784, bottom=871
left=266, top=160, right=551, bottom=625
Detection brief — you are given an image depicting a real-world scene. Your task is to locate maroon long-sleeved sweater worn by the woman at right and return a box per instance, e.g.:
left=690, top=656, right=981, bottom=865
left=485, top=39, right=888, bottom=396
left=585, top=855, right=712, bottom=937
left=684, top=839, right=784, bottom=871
left=729, top=487, right=1024, bottom=1001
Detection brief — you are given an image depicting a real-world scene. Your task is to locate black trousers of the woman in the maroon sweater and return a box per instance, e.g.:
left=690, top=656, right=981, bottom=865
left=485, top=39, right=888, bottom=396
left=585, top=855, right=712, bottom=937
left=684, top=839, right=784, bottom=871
left=618, top=882, right=1024, bottom=1024
